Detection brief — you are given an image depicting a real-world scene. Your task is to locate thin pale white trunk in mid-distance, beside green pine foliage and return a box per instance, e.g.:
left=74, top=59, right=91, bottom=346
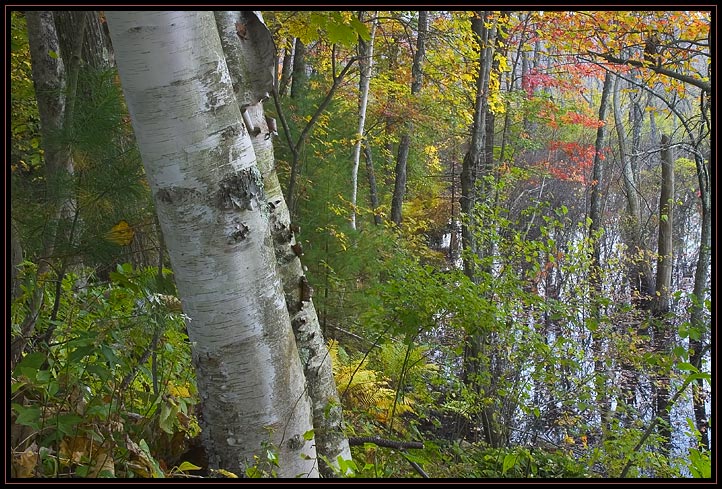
left=351, top=11, right=377, bottom=229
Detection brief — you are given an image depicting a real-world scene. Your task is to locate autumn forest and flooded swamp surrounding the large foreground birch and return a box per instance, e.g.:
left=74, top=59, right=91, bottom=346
left=6, top=9, right=716, bottom=478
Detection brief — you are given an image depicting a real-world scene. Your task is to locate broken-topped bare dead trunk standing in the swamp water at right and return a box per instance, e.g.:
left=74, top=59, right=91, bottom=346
left=653, top=134, right=674, bottom=456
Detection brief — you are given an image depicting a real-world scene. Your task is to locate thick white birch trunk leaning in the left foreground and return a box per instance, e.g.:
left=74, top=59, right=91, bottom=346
left=107, top=11, right=318, bottom=477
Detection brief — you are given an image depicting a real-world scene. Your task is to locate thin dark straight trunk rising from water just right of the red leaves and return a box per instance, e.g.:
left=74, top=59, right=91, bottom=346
left=589, top=68, right=612, bottom=433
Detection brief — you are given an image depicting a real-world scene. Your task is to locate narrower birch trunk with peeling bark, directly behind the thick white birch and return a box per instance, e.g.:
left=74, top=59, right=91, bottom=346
left=215, top=11, right=351, bottom=477
